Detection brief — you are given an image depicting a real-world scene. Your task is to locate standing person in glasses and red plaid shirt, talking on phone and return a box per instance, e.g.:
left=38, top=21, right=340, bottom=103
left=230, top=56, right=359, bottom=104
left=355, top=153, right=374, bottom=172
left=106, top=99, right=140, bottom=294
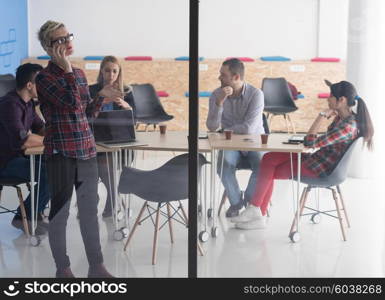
left=36, top=21, right=122, bottom=278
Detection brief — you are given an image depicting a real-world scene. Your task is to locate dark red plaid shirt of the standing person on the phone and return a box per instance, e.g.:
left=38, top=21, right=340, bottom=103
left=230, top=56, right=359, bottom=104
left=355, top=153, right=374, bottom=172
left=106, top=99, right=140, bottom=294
left=36, top=61, right=102, bottom=160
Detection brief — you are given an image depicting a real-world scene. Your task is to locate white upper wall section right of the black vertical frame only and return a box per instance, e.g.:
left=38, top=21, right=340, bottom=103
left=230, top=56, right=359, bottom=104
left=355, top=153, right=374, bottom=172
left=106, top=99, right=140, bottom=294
left=200, top=0, right=317, bottom=58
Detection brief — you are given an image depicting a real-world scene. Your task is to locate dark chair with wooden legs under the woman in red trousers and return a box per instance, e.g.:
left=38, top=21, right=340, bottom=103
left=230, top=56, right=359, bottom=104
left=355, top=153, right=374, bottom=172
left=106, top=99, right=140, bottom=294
left=289, top=138, right=362, bottom=242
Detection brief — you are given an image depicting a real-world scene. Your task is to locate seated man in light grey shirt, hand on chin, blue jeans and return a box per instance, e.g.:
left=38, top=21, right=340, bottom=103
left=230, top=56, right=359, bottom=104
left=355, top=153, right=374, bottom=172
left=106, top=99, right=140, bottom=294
left=206, top=58, right=265, bottom=218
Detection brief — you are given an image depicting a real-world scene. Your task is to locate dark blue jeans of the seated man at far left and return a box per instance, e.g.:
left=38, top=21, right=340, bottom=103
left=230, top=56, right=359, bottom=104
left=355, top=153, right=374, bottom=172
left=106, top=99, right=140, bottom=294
left=0, top=156, right=50, bottom=219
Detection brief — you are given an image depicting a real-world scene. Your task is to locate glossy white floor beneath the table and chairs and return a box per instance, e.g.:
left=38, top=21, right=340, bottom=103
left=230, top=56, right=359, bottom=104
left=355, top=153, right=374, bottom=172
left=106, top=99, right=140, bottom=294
left=0, top=152, right=385, bottom=277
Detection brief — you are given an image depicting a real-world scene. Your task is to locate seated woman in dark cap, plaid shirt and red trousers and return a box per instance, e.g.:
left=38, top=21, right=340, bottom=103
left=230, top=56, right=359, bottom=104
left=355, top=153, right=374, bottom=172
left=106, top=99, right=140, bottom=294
left=231, top=80, right=374, bottom=229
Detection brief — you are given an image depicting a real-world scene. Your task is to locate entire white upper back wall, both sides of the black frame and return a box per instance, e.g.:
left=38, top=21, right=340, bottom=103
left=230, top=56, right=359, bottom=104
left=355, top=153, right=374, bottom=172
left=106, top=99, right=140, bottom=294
left=29, top=0, right=347, bottom=59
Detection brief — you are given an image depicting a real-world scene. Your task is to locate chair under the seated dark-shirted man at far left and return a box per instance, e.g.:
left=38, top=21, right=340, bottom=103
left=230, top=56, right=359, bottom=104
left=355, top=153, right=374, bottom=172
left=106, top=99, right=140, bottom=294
left=0, top=177, right=31, bottom=237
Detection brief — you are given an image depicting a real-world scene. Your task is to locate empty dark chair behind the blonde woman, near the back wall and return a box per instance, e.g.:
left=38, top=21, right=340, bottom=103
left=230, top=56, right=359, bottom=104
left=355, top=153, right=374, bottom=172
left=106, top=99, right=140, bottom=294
left=132, top=83, right=174, bottom=131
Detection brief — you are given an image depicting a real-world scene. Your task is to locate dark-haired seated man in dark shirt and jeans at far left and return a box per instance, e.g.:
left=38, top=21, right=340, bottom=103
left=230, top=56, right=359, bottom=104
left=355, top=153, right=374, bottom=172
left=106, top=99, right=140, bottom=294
left=0, top=63, right=49, bottom=235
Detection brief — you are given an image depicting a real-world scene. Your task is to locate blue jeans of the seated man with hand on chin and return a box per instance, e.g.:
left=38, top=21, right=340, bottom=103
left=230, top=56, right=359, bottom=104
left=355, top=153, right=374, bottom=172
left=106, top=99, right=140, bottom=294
left=217, top=150, right=264, bottom=206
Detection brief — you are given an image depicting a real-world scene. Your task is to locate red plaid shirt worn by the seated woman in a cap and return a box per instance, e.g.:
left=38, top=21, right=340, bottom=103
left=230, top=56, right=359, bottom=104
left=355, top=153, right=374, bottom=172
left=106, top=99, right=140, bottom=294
left=304, top=115, right=358, bottom=177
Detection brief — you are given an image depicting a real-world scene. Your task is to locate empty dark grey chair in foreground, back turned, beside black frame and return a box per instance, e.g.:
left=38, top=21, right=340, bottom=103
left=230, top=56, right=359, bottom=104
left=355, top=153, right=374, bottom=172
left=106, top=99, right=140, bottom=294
left=118, top=154, right=208, bottom=265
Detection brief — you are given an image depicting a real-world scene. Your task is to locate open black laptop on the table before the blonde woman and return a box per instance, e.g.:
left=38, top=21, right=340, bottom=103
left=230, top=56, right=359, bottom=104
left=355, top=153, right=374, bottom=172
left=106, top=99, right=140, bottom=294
left=92, top=109, right=147, bottom=148
